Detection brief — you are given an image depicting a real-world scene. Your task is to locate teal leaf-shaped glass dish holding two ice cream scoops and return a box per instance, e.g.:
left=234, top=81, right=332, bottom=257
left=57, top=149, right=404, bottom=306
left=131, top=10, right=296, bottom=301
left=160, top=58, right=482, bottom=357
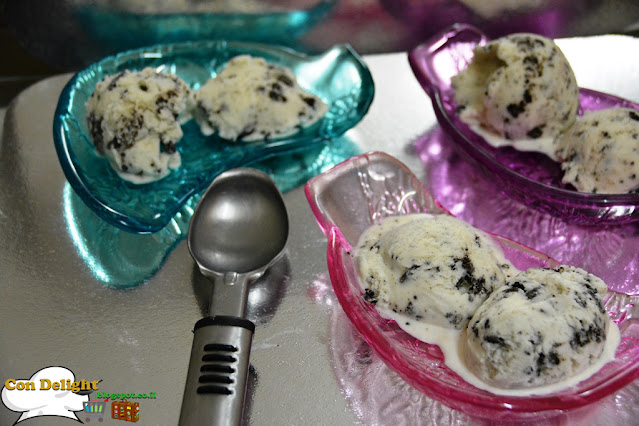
left=53, top=41, right=375, bottom=233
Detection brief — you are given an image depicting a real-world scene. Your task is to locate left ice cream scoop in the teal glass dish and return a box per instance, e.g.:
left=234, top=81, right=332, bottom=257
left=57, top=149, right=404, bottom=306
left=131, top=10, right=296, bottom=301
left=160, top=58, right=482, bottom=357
left=86, top=68, right=190, bottom=183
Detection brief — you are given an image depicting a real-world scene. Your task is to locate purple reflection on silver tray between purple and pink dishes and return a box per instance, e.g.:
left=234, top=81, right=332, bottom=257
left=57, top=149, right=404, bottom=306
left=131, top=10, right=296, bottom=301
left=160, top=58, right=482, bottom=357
left=415, top=128, right=639, bottom=295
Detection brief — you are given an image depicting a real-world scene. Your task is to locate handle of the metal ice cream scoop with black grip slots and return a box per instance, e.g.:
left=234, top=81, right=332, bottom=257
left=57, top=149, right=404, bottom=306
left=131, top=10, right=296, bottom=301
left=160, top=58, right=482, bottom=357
left=179, top=316, right=255, bottom=426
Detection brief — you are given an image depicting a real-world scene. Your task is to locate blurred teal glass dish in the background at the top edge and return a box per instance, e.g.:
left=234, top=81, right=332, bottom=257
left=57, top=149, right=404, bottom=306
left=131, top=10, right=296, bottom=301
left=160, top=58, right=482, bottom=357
left=75, top=0, right=337, bottom=52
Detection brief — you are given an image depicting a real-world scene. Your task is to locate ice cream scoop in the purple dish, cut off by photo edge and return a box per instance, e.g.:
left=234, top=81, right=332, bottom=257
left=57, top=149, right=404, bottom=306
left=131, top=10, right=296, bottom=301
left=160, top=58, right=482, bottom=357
left=557, top=108, right=639, bottom=194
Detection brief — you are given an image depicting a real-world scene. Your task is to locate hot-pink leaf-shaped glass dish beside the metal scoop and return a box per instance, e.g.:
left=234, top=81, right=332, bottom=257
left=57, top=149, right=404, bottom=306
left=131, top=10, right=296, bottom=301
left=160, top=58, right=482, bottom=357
left=305, top=152, right=639, bottom=419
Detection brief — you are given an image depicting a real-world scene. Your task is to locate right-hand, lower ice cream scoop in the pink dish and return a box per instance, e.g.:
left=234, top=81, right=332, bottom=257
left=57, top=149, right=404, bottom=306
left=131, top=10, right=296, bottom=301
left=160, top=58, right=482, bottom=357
left=464, top=266, right=610, bottom=389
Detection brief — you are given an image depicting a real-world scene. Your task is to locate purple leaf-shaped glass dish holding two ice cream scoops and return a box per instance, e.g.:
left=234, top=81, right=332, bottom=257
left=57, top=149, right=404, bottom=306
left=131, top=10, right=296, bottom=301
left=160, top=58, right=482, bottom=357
left=408, top=25, right=639, bottom=225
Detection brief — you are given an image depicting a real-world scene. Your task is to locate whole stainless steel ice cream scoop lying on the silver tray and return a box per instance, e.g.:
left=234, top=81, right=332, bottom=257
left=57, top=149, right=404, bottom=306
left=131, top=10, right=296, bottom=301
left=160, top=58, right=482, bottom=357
left=180, top=168, right=288, bottom=426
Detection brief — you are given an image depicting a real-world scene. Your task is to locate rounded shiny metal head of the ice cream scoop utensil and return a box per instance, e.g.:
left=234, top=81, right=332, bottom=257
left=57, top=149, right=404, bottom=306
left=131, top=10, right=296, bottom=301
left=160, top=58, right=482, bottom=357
left=188, top=168, right=288, bottom=276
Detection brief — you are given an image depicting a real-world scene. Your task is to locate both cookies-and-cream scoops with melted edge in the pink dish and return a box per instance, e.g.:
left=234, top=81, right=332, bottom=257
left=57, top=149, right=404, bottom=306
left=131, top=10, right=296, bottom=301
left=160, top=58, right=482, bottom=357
left=354, top=214, right=620, bottom=396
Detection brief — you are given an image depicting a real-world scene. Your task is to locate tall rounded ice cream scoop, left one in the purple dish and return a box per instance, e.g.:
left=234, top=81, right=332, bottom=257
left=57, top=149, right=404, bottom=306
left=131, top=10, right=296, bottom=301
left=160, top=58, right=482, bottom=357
left=452, top=33, right=579, bottom=146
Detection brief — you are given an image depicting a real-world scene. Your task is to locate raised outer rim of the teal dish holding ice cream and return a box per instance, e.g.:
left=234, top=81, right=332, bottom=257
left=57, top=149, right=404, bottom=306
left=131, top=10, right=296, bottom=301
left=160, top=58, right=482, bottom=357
left=53, top=40, right=375, bottom=234
